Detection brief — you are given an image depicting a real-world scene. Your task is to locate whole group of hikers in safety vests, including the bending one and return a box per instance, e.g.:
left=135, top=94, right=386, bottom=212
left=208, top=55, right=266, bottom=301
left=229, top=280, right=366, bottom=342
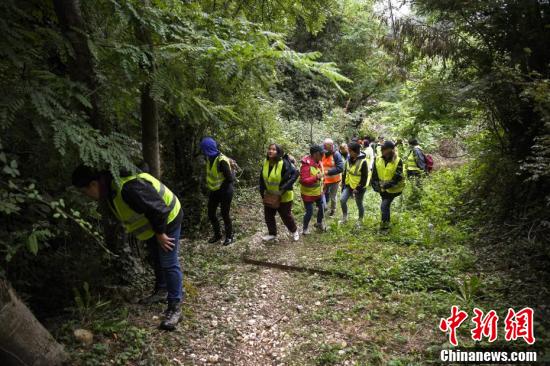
left=68, top=137, right=433, bottom=330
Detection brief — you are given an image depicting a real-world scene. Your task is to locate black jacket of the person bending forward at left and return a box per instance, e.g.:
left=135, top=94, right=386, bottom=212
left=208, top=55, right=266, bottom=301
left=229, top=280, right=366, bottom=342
left=106, top=173, right=183, bottom=234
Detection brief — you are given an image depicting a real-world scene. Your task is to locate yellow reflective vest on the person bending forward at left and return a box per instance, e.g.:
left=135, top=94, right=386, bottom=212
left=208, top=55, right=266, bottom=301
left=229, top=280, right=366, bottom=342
left=111, top=173, right=181, bottom=240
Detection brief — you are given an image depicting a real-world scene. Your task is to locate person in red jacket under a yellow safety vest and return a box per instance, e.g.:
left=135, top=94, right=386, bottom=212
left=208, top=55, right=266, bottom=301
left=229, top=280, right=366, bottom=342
left=300, top=145, right=326, bottom=235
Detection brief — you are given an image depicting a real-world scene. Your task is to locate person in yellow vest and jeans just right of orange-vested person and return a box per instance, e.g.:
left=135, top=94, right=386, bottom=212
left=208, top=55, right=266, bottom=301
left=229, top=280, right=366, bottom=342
left=340, top=142, right=369, bottom=224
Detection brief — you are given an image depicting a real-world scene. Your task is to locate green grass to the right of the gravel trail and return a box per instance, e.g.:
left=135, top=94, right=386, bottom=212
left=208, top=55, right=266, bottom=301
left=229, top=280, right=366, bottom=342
left=278, top=169, right=544, bottom=365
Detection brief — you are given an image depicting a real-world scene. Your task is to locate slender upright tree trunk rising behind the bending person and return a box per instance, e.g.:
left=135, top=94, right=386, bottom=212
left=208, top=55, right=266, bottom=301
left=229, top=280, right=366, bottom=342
left=134, top=1, right=161, bottom=178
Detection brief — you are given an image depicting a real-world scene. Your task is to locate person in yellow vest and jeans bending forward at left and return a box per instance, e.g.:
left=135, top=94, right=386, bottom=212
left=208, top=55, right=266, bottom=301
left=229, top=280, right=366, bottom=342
left=72, top=165, right=184, bottom=330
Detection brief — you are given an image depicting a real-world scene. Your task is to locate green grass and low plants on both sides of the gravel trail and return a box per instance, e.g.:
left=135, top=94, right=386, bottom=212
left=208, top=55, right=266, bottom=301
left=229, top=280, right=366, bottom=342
left=58, top=165, right=548, bottom=365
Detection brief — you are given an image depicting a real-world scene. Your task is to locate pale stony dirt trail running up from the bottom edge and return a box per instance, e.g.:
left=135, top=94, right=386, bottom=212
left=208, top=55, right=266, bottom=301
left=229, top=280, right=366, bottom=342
left=177, top=234, right=324, bottom=365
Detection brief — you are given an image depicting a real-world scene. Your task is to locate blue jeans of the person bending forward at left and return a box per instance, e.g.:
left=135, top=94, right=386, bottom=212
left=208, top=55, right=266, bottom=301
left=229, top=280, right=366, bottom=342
left=147, top=226, right=183, bottom=303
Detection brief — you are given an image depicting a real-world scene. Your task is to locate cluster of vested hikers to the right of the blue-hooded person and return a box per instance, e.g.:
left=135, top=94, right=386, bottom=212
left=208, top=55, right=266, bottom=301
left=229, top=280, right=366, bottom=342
left=259, top=137, right=433, bottom=237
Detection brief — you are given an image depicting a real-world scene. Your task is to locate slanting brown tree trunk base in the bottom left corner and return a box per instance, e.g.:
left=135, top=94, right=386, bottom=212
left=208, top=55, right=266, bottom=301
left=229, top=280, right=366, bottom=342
left=0, top=280, right=67, bottom=366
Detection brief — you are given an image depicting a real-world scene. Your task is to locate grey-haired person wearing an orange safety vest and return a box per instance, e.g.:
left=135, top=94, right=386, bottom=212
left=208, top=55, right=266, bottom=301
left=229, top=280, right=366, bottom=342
left=322, top=138, right=344, bottom=217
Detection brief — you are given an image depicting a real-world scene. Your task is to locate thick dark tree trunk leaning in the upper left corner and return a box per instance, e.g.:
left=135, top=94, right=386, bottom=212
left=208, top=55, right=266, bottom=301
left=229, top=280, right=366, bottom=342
left=53, top=0, right=108, bottom=132
